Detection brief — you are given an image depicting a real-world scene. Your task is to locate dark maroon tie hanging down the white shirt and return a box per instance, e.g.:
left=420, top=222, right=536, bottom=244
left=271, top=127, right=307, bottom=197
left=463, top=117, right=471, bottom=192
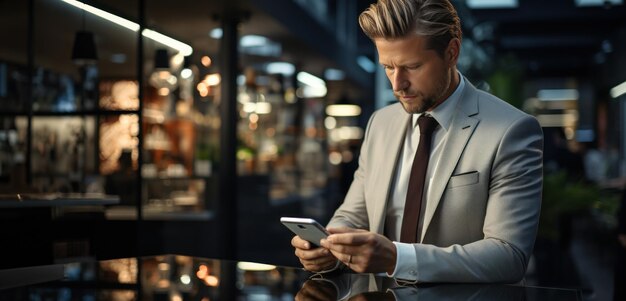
left=400, top=115, right=438, bottom=243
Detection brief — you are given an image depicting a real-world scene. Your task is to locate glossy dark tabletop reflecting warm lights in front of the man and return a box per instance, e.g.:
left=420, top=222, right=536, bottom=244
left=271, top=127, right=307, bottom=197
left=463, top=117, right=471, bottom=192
left=0, top=255, right=582, bottom=301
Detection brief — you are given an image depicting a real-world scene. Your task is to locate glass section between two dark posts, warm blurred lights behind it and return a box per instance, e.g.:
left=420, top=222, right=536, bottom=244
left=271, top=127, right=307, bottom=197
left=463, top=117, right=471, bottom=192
left=141, top=0, right=221, bottom=220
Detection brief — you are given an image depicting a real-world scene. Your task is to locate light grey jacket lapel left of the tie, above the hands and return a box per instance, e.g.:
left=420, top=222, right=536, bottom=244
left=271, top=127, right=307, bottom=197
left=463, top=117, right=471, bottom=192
left=368, top=103, right=412, bottom=234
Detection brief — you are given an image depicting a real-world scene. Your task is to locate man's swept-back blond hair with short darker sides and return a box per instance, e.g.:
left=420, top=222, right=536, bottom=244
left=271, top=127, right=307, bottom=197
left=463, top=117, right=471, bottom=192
left=359, top=0, right=462, bottom=56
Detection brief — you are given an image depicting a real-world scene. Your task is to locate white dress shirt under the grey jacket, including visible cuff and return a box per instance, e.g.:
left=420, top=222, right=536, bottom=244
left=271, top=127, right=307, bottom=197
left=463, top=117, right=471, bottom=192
left=385, top=73, right=465, bottom=279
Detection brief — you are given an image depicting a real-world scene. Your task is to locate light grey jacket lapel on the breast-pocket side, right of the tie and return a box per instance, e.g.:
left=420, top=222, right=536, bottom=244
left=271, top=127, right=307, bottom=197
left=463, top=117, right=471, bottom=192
left=420, top=78, right=480, bottom=241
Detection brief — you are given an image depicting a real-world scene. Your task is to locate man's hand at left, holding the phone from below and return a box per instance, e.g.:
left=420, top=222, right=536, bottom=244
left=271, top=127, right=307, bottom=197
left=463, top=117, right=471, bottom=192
left=291, top=235, right=337, bottom=272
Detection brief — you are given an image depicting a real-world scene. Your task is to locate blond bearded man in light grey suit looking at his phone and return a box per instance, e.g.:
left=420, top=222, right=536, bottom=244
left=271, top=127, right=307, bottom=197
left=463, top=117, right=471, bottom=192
left=292, top=0, right=543, bottom=283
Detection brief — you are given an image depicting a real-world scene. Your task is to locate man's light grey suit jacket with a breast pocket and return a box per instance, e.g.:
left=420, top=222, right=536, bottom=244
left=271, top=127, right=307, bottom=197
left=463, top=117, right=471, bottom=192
left=328, top=79, right=543, bottom=283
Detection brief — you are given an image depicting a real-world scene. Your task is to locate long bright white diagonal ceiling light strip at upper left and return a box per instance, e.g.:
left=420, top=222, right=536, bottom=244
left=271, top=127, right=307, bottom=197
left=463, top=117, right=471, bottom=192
left=61, top=0, right=193, bottom=56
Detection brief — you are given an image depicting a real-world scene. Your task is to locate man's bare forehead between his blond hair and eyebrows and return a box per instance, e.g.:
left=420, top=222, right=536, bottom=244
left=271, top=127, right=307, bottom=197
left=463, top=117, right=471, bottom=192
left=374, top=35, right=436, bottom=64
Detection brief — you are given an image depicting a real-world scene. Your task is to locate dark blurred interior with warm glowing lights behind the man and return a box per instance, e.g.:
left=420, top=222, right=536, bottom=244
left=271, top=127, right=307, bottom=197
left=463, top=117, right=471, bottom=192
left=0, top=0, right=626, bottom=300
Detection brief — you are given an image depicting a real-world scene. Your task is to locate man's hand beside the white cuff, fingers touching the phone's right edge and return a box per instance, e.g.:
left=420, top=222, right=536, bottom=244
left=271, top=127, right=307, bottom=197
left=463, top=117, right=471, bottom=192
left=321, top=227, right=397, bottom=274
